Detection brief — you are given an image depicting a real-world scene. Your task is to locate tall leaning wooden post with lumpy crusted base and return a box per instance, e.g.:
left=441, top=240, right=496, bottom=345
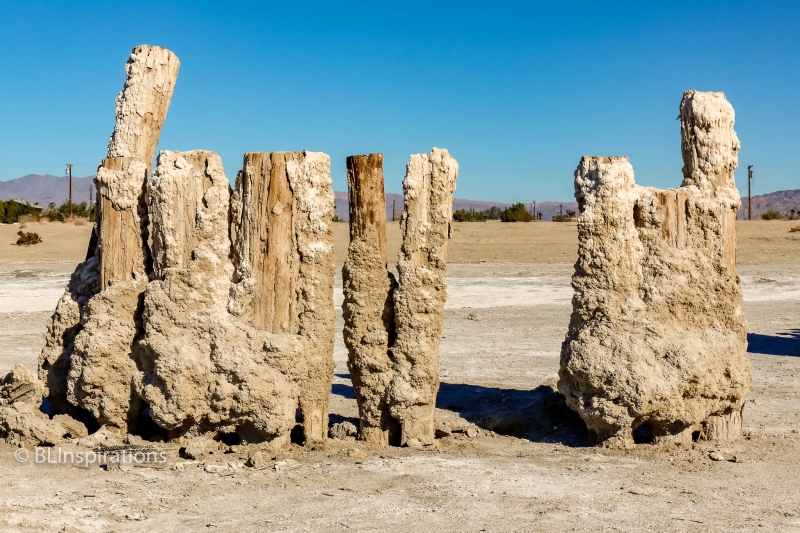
left=67, top=45, right=179, bottom=432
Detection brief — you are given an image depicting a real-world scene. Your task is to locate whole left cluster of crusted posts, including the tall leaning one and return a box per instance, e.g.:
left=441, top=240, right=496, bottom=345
left=36, top=46, right=335, bottom=445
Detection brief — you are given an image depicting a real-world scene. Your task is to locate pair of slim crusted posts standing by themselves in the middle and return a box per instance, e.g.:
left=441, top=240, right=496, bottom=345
left=343, top=148, right=458, bottom=445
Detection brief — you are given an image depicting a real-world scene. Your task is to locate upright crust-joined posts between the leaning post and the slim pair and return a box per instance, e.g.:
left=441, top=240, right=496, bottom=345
left=141, top=151, right=334, bottom=446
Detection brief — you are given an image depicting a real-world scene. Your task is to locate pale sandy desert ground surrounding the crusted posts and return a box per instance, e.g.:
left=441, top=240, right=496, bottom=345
left=0, top=221, right=800, bottom=531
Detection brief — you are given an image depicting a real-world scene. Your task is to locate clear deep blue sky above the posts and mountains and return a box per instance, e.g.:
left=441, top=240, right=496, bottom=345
left=0, top=0, right=800, bottom=202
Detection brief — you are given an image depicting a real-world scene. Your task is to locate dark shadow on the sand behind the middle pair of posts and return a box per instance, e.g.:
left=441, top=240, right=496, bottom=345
left=333, top=374, right=589, bottom=447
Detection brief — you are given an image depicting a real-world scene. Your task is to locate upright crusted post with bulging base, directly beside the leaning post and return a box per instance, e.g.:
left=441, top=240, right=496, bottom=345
left=140, top=150, right=302, bottom=443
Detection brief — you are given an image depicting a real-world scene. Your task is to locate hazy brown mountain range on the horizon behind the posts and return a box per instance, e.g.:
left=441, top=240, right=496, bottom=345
left=0, top=174, right=800, bottom=220
